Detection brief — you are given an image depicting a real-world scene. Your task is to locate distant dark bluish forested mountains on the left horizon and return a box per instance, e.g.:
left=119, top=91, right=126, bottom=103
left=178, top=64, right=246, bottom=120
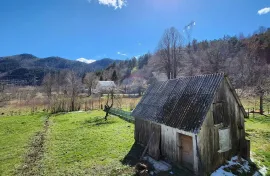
left=0, top=54, right=119, bottom=85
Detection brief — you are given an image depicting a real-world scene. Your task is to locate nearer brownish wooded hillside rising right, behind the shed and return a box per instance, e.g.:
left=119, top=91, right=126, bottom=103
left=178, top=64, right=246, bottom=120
left=99, top=27, right=270, bottom=89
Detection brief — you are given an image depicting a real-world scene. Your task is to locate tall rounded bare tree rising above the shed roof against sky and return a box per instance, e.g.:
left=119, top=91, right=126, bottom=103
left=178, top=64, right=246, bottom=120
left=157, top=27, right=182, bottom=79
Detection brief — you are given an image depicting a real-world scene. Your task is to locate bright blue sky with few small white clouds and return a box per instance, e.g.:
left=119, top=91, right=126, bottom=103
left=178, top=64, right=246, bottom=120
left=0, top=0, right=270, bottom=60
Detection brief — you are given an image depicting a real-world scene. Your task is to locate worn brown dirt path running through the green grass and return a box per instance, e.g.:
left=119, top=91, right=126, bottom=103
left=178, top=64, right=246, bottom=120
left=16, top=115, right=50, bottom=176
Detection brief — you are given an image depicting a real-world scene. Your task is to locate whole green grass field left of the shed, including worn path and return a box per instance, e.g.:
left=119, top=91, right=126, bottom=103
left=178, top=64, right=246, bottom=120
left=0, top=111, right=134, bottom=176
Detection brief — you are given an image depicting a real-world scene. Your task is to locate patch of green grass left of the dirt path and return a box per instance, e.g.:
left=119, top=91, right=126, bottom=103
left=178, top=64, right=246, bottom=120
left=0, top=113, right=46, bottom=175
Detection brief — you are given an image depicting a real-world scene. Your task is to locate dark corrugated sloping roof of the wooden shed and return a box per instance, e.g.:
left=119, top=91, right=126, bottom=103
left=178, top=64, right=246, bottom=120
left=132, top=73, right=224, bottom=133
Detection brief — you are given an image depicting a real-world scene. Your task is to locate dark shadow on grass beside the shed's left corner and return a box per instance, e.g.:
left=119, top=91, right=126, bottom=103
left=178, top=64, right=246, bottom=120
left=120, top=143, right=144, bottom=166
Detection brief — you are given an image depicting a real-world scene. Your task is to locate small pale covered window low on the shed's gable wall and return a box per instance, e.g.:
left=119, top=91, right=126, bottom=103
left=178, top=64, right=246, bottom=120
left=218, top=128, right=231, bottom=152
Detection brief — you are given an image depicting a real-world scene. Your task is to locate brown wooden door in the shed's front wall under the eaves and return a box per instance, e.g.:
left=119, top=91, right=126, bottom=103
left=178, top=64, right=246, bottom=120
left=178, top=133, right=194, bottom=170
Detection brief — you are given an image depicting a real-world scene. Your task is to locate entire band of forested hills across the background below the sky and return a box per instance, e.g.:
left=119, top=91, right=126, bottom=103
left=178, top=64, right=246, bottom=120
left=0, top=27, right=270, bottom=90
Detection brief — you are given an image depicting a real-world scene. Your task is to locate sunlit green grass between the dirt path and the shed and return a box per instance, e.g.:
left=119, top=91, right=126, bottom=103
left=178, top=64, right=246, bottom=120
left=43, top=111, right=134, bottom=175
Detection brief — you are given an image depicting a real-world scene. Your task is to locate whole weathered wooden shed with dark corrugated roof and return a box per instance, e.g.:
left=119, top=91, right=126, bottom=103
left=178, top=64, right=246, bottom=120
left=132, top=73, right=250, bottom=175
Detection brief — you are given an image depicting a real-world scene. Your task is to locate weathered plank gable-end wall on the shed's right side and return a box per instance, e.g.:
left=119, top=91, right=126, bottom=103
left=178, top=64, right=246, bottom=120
left=198, top=80, right=248, bottom=173
